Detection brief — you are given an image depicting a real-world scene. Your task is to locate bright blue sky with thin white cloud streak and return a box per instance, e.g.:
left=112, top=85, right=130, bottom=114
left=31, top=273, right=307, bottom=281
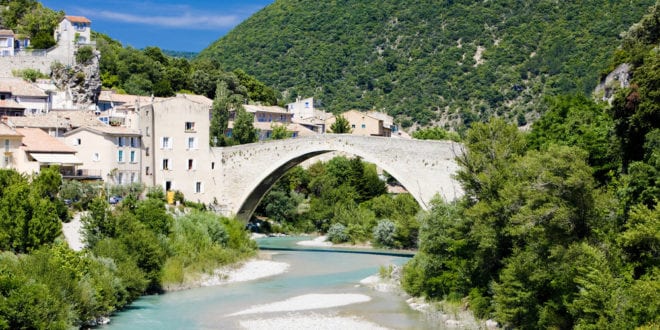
left=41, top=0, right=274, bottom=52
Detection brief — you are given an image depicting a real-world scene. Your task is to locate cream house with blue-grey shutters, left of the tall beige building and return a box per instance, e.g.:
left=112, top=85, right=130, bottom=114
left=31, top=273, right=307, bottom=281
left=63, top=125, right=142, bottom=184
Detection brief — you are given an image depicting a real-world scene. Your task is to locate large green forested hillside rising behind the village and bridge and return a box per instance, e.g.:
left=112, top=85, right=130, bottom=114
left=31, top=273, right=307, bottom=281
left=198, top=0, right=655, bottom=126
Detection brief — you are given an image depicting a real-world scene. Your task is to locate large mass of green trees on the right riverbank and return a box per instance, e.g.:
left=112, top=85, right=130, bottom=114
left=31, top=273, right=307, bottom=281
left=403, top=5, right=660, bottom=329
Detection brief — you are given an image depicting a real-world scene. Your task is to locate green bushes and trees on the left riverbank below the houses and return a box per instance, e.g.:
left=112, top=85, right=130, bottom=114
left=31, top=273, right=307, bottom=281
left=0, top=175, right=256, bottom=329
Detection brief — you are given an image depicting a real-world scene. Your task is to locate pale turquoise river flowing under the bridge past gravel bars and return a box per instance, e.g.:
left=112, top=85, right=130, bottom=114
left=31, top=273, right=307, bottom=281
left=103, top=237, right=438, bottom=329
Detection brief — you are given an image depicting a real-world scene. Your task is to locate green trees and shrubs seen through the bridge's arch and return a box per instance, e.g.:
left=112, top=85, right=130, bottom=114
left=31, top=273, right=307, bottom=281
left=256, top=157, right=419, bottom=249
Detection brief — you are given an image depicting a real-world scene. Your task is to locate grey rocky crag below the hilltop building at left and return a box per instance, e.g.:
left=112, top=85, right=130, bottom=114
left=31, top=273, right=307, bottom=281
left=51, top=50, right=101, bottom=109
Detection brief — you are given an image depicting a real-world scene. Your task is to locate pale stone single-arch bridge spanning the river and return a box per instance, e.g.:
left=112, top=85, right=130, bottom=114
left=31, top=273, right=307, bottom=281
left=212, top=134, right=462, bottom=220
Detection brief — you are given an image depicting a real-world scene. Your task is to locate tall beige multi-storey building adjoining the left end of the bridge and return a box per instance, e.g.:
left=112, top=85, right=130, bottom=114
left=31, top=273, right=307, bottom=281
left=138, top=94, right=216, bottom=202
